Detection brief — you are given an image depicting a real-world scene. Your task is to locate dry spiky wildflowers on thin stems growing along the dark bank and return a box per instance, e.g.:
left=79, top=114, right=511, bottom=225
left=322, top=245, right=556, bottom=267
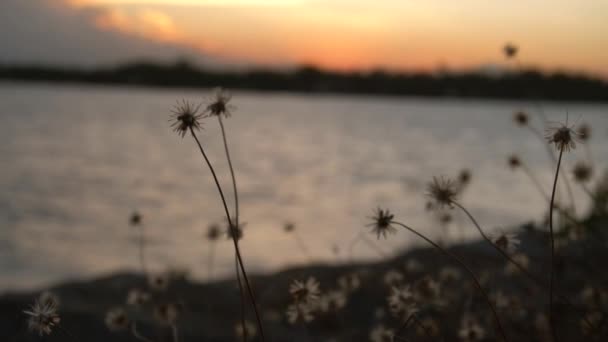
left=24, top=44, right=608, bottom=342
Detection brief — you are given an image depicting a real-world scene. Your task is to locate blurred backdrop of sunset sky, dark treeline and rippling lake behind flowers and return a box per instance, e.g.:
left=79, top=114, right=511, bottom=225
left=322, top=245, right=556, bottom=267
left=0, top=0, right=608, bottom=291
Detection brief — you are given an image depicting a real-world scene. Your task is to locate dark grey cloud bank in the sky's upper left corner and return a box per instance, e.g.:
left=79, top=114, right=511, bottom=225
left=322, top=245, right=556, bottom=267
left=0, top=0, right=217, bottom=66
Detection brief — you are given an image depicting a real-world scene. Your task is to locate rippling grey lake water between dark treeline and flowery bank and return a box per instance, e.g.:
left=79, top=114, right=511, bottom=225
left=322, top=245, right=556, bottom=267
left=0, top=83, right=608, bottom=291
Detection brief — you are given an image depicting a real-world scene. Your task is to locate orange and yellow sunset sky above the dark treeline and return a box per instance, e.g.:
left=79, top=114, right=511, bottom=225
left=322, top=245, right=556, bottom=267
left=0, top=0, right=608, bottom=77
